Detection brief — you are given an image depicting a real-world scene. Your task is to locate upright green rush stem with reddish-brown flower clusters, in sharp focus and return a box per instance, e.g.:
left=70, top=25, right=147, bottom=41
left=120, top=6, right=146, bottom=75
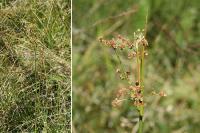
left=99, top=30, right=165, bottom=133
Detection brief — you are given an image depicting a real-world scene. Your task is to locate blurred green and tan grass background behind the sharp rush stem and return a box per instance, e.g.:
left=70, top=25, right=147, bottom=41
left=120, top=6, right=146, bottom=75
left=73, top=0, right=200, bottom=133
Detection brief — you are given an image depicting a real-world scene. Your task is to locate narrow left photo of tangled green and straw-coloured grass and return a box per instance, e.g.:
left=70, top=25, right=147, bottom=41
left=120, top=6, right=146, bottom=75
left=0, top=0, right=71, bottom=133
